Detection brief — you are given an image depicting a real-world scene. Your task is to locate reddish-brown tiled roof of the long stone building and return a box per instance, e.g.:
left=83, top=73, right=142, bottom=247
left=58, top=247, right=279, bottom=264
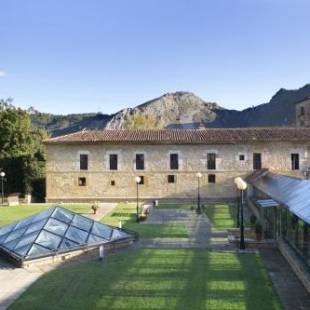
left=45, top=127, right=310, bottom=144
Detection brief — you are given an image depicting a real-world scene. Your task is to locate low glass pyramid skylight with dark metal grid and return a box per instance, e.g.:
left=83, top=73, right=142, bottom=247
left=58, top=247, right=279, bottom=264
left=0, top=206, right=134, bottom=261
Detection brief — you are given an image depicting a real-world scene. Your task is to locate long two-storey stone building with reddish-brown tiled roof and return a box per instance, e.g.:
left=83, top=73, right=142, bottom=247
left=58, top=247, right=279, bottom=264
left=45, top=128, right=310, bottom=202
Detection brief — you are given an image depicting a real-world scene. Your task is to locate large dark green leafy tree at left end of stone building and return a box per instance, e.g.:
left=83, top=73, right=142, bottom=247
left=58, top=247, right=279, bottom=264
left=0, top=99, right=48, bottom=201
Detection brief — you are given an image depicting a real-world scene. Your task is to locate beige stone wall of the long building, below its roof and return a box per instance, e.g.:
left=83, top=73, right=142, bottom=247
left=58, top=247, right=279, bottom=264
left=46, top=142, right=310, bottom=202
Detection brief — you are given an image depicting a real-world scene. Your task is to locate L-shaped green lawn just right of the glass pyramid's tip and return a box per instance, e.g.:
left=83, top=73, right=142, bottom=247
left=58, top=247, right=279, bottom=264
left=101, top=203, right=188, bottom=238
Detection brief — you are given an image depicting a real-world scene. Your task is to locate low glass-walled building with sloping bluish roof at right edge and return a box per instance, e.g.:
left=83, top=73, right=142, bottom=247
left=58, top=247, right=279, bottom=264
left=247, top=171, right=310, bottom=291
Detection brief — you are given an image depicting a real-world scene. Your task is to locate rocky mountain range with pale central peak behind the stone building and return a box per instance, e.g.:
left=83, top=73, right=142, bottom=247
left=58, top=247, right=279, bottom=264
left=29, top=84, right=310, bottom=136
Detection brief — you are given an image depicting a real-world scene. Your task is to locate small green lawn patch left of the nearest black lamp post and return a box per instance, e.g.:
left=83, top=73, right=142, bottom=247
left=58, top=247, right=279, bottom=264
left=205, top=203, right=237, bottom=230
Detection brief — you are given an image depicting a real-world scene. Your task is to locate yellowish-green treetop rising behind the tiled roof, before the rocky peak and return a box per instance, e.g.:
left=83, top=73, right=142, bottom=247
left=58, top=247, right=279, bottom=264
left=124, top=114, right=163, bottom=129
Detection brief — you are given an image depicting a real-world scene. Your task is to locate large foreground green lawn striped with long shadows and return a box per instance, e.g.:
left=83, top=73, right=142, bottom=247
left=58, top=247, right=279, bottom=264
left=10, top=249, right=282, bottom=310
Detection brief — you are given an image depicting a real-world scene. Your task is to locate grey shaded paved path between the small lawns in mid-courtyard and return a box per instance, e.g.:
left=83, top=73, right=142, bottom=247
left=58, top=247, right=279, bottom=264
left=139, top=208, right=235, bottom=250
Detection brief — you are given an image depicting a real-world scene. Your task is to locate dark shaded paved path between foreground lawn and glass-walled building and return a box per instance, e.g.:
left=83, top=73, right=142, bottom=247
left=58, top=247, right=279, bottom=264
left=260, top=249, right=310, bottom=310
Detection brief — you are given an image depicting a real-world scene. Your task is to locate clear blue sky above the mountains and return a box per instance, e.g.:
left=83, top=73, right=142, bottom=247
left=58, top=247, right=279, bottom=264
left=0, top=0, right=310, bottom=114
